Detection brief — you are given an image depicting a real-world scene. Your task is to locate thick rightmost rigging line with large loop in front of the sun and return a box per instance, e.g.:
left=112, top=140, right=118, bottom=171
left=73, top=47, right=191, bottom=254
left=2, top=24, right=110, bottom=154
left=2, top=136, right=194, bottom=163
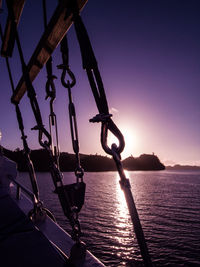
left=74, top=6, right=152, bottom=267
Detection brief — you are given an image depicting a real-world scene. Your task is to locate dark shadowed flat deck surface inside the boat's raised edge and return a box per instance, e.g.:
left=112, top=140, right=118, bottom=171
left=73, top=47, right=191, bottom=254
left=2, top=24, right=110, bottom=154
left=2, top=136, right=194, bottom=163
left=0, top=189, right=70, bottom=267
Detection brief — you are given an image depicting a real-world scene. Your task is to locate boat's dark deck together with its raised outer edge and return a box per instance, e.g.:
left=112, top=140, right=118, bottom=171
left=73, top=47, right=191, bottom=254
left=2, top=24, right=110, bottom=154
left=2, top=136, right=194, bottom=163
left=0, top=188, right=104, bottom=267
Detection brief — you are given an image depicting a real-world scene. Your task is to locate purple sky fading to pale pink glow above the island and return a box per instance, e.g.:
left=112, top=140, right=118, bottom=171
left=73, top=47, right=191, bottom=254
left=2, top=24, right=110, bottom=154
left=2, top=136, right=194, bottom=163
left=0, top=0, right=200, bottom=165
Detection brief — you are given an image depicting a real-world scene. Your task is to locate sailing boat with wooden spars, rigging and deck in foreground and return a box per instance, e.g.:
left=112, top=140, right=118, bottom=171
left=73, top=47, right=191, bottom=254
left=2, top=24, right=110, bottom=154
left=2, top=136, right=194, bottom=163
left=0, top=0, right=152, bottom=267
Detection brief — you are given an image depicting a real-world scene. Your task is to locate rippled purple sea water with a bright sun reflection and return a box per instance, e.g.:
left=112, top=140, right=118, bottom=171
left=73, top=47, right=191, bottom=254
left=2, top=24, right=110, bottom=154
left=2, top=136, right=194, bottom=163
left=16, top=171, right=200, bottom=267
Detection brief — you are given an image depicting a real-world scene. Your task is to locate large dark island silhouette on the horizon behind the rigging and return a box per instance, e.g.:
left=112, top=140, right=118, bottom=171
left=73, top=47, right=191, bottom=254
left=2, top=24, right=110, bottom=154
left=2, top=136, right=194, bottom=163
left=2, top=147, right=165, bottom=172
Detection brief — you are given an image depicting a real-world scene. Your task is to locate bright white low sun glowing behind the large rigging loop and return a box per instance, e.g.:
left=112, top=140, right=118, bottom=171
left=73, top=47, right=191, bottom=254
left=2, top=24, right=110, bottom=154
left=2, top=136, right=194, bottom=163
left=108, top=126, right=139, bottom=159
